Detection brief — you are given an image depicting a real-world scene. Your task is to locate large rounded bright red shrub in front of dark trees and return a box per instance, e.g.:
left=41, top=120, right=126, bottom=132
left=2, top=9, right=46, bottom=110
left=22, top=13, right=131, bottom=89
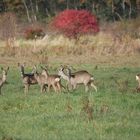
left=51, top=10, right=99, bottom=38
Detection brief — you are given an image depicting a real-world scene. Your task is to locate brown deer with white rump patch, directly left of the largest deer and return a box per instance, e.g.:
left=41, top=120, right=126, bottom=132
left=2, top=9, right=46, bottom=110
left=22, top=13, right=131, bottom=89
left=41, top=67, right=63, bottom=92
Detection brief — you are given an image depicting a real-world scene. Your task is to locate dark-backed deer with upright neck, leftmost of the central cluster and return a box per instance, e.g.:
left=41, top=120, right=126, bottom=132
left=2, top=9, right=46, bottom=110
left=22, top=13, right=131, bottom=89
left=18, top=63, right=37, bottom=94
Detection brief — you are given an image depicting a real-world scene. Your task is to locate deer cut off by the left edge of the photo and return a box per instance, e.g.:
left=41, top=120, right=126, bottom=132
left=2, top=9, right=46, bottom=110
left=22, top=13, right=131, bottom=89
left=0, top=67, right=9, bottom=95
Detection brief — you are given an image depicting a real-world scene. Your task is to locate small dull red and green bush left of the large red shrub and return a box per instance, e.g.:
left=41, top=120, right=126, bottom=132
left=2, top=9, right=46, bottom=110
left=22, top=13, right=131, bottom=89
left=24, top=27, right=45, bottom=39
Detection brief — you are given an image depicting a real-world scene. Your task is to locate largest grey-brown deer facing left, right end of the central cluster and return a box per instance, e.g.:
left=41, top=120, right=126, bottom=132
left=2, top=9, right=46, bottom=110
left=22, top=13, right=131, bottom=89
left=58, top=67, right=97, bottom=92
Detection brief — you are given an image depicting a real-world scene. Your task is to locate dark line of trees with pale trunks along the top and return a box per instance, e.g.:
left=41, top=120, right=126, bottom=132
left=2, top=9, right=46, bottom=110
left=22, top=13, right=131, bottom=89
left=0, top=0, right=140, bottom=23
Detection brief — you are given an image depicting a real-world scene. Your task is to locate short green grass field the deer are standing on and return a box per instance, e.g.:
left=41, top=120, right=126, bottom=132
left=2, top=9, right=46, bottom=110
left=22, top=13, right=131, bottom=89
left=0, top=64, right=140, bottom=140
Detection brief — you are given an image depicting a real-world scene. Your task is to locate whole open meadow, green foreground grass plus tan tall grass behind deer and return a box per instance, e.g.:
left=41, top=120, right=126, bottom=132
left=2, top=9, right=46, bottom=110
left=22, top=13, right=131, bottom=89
left=0, top=18, right=140, bottom=140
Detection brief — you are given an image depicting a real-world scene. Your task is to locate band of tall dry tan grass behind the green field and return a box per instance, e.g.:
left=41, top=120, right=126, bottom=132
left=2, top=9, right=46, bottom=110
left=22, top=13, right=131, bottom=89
left=0, top=19, right=140, bottom=63
